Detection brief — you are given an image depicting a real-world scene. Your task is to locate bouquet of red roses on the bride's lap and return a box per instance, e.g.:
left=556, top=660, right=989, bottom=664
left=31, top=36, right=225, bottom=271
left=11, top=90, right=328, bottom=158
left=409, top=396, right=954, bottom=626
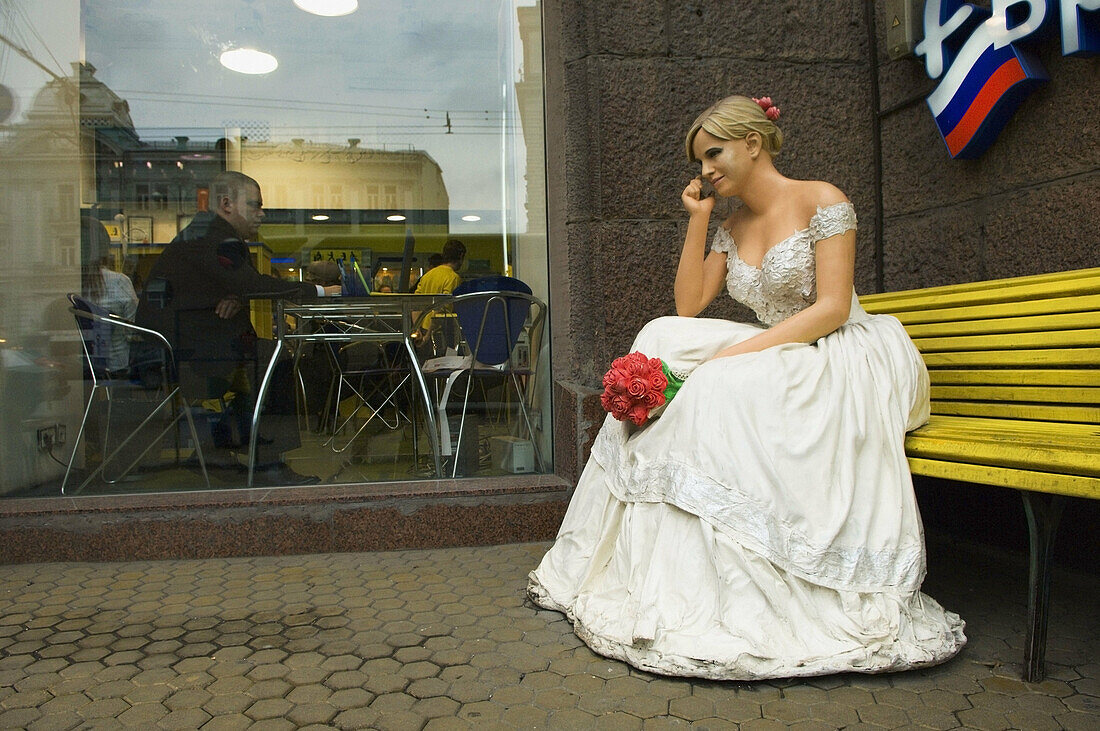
left=600, top=352, right=684, bottom=427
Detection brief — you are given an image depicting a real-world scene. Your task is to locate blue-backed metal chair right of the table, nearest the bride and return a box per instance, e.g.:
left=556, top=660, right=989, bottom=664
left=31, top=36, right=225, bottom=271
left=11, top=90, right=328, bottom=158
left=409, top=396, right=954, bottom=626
left=419, top=277, right=546, bottom=477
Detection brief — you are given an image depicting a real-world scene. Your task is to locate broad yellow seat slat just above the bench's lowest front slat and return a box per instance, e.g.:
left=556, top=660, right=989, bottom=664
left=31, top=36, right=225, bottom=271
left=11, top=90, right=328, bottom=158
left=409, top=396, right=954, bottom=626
left=905, top=433, right=1100, bottom=477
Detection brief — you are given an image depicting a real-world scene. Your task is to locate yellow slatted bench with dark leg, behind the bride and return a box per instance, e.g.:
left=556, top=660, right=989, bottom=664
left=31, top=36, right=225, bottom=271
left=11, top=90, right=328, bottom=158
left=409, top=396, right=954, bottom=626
left=860, top=268, right=1100, bottom=680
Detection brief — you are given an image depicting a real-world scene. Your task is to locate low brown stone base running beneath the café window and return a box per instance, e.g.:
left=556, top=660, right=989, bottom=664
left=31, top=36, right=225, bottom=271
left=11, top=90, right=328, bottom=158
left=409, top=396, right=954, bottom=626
left=0, top=475, right=571, bottom=564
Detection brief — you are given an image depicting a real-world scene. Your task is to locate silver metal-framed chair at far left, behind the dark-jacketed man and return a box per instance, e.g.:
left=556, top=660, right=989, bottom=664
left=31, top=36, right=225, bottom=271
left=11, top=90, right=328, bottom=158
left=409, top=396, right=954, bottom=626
left=62, top=295, right=210, bottom=495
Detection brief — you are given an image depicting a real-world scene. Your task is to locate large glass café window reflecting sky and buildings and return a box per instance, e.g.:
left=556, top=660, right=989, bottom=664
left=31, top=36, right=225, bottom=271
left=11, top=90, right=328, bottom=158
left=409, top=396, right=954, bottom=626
left=0, top=0, right=552, bottom=496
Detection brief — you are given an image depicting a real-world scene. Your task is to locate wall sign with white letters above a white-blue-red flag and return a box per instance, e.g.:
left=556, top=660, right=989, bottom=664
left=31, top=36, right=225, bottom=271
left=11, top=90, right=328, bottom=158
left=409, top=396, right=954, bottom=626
left=914, top=0, right=1100, bottom=158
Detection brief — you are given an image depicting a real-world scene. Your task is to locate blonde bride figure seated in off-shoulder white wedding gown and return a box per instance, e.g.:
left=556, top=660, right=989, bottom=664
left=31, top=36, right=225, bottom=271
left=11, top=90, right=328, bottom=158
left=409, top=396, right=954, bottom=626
left=528, top=97, right=966, bottom=679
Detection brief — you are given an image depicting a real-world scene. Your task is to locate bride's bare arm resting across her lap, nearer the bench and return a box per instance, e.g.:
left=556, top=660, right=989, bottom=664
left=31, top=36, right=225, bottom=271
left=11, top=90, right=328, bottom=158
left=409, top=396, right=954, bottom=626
left=714, top=225, right=856, bottom=358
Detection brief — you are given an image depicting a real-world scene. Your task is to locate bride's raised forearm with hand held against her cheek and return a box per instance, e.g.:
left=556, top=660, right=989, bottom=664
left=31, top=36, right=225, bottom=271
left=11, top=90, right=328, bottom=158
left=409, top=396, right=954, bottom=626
left=673, top=178, right=726, bottom=318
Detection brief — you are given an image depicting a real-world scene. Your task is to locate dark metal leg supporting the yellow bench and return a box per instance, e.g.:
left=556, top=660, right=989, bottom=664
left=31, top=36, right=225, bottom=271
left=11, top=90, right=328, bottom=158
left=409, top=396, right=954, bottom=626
left=1020, top=490, right=1065, bottom=683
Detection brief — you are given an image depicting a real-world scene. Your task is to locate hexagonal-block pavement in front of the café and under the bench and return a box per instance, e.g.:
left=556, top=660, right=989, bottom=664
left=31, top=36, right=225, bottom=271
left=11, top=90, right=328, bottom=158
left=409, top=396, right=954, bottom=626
left=0, top=534, right=1100, bottom=730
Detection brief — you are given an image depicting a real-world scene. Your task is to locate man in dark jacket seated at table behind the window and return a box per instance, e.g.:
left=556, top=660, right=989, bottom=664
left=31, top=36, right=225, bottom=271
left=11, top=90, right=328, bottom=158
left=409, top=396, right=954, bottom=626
left=136, top=171, right=340, bottom=484
